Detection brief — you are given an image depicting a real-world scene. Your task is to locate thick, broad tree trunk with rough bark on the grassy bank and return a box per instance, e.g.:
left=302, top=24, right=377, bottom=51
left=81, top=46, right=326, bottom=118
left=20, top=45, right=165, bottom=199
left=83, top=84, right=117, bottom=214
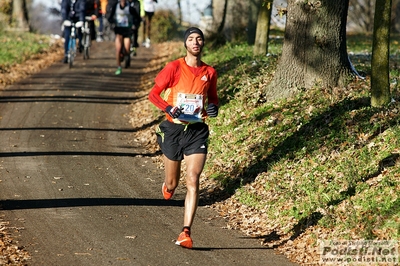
left=266, top=0, right=354, bottom=99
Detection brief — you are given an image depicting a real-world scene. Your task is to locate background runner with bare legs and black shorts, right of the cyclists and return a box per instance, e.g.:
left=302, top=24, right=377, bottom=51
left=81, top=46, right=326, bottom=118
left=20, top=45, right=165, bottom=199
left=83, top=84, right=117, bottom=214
left=108, top=0, right=140, bottom=75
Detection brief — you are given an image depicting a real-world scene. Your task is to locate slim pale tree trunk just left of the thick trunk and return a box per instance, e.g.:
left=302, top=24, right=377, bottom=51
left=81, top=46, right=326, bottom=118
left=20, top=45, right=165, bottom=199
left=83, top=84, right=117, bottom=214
left=253, top=0, right=272, bottom=55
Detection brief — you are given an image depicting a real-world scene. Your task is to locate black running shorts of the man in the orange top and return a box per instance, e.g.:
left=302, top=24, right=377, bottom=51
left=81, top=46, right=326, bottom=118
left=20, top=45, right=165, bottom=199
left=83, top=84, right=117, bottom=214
left=156, top=120, right=210, bottom=161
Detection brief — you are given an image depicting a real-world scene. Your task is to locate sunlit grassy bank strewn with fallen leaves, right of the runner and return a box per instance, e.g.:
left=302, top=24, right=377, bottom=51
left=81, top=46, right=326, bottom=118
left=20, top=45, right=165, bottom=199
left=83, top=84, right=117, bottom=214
left=203, top=31, right=400, bottom=243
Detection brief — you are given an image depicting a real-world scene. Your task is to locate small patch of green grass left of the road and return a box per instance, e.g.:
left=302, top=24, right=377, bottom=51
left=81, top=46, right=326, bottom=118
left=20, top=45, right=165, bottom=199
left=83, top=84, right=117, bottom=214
left=0, top=31, right=55, bottom=73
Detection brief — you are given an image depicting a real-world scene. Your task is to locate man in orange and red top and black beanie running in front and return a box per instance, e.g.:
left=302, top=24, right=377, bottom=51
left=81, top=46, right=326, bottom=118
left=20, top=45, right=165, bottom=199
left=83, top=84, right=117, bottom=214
left=148, top=27, right=218, bottom=248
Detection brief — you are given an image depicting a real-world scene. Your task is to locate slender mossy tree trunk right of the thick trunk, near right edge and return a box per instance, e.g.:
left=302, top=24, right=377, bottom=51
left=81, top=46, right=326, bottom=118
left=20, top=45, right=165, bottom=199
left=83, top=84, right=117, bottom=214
left=371, top=0, right=392, bottom=107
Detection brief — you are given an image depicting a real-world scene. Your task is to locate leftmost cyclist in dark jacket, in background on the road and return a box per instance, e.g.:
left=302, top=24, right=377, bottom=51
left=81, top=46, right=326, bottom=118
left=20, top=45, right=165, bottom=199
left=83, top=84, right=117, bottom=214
left=61, top=0, right=85, bottom=64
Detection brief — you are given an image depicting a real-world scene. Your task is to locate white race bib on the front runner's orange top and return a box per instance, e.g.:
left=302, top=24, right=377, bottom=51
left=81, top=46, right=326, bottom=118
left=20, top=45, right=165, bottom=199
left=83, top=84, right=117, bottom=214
left=176, top=93, right=203, bottom=123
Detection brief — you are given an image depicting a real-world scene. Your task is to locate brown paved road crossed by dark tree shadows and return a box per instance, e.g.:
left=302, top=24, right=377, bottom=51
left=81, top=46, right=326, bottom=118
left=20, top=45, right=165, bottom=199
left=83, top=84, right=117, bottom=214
left=0, top=42, right=294, bottom=266
